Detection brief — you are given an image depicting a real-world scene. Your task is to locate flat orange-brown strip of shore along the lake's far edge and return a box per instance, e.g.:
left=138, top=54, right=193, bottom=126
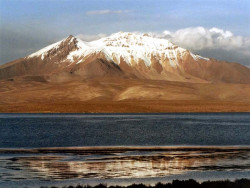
left=0, top=100, right=250, bottom=114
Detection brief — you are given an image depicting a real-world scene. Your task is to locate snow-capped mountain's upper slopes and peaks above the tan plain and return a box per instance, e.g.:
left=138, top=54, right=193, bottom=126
left=0, top=32, right=250, bottom=84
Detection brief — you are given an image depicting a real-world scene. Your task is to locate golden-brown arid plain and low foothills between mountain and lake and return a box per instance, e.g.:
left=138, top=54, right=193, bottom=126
left=0, top=76, right=250, bottom=113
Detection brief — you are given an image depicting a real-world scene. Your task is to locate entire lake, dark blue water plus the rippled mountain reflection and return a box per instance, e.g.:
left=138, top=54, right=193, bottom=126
left=0, top=113, right=250, bottom=187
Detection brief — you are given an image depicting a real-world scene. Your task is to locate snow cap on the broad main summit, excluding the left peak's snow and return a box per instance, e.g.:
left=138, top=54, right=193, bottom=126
left=90, top=32, right=186, bottom=66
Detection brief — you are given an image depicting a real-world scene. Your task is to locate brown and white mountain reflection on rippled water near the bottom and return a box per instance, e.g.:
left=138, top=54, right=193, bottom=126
left=0, top=147, right=250, bottom=182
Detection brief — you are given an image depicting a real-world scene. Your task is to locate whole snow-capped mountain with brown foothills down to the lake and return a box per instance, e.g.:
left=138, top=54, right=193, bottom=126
left=0, top=32, right=250, bottom=112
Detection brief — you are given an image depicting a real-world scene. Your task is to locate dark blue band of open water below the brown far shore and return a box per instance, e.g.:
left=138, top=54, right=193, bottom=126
left=0, top=113, right=250, bottom=148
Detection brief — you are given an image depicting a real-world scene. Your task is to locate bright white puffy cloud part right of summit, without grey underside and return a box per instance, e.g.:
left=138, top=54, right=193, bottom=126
left=153, top=27, right=249, bottom=50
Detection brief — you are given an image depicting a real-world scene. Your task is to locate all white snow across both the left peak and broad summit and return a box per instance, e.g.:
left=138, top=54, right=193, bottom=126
left=28, top=32, right=209, bottom=67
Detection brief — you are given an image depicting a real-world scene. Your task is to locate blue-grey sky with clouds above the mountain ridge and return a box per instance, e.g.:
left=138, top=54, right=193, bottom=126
left=0, top=0, right=250, bottom=67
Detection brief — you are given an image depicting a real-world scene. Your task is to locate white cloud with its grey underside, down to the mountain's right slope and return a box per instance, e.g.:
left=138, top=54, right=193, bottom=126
left=151, top=27, right=250, bottom=65
